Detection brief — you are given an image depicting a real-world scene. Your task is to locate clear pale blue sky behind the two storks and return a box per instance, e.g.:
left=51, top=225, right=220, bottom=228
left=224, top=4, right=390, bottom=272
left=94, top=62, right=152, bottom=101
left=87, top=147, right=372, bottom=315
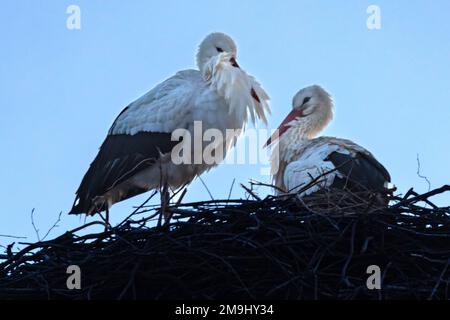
left=0, top=0, right=450, bottom=245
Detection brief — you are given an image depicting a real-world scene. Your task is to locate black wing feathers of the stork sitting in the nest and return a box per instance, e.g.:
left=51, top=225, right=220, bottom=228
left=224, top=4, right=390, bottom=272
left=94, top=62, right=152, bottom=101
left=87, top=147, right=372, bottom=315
left=327, top=151, right=391, bottom=192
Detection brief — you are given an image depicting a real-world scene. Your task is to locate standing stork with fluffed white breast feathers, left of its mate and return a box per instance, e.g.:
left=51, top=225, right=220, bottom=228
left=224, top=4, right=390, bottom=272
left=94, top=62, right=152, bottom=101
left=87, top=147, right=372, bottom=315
left=70, top=33, right=270, bottom=214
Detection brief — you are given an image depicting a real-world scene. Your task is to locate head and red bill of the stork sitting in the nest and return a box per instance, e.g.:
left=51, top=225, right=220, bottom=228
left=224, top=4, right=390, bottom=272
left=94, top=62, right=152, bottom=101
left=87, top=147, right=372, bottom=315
left=266, top=85, right=333, bottom=145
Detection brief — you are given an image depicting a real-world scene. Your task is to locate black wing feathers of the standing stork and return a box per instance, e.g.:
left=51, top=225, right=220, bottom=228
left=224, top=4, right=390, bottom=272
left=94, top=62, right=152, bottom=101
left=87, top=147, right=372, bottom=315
left=69, top=132, right=179, bottom=214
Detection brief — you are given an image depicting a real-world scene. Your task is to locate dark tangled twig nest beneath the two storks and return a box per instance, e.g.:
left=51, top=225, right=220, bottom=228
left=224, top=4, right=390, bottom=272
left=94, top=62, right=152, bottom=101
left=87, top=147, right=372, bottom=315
left=0, top=186, right=450, bottom=299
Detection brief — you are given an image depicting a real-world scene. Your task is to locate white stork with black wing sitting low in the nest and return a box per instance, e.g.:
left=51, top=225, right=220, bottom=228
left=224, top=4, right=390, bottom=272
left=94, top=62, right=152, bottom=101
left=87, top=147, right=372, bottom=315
left=266, top=85, right=391, bottom=197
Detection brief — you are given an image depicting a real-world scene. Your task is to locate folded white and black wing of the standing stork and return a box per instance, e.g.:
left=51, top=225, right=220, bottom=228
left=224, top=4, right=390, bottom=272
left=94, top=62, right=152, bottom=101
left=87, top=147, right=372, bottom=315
left=70, top=70, right=202, bottom=214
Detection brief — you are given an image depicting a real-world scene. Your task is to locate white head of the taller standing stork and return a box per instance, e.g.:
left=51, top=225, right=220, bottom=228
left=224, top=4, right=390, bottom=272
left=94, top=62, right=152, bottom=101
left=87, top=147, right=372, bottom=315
left=197, top=32, right=239, bottom=73
